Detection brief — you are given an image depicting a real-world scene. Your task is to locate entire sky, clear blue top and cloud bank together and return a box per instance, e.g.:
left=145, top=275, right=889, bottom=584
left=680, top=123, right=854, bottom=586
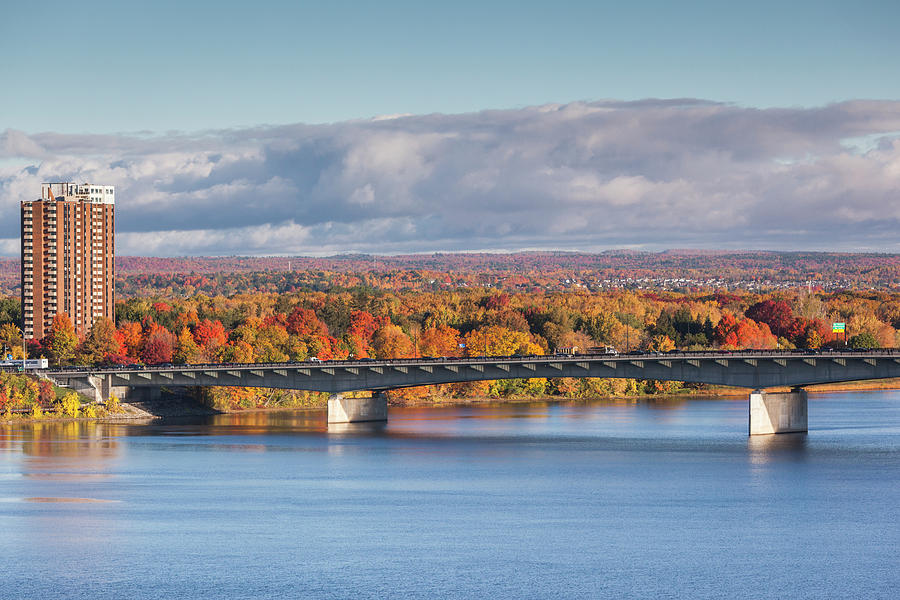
left=0, top=0, right=900, bottom=256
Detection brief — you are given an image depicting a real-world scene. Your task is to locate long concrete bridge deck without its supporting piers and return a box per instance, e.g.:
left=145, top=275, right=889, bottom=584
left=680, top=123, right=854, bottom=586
left=29, top=349, right=900, bottom=394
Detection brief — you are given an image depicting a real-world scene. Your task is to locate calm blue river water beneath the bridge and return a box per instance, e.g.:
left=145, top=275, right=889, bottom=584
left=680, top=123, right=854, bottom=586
left=0, top=392, right=900, bottom=599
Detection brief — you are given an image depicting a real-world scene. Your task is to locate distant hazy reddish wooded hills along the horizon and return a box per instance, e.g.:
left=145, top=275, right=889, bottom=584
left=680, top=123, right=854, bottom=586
left=0, top=250, right=900, bottom=296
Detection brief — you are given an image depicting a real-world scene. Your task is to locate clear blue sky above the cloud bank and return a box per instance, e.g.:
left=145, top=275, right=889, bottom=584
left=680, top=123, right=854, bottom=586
left=0, top=0, right=900, bottom=133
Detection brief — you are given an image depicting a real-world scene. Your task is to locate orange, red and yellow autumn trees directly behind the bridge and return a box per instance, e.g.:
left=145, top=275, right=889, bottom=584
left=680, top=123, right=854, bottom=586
left=0, top=288, right=900, bottom=410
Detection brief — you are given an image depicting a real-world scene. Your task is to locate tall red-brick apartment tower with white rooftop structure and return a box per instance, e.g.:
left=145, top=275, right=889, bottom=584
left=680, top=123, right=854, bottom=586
left=22, top=183, right=115, bottom=339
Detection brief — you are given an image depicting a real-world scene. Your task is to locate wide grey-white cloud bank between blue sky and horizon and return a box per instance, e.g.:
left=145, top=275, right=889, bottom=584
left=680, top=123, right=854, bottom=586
left=0, top=99, right=900, bottom=255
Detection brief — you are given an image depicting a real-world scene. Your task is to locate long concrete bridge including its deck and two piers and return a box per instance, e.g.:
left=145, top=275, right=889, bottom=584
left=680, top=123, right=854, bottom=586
left=38, top=349, right=900, bottom=435
